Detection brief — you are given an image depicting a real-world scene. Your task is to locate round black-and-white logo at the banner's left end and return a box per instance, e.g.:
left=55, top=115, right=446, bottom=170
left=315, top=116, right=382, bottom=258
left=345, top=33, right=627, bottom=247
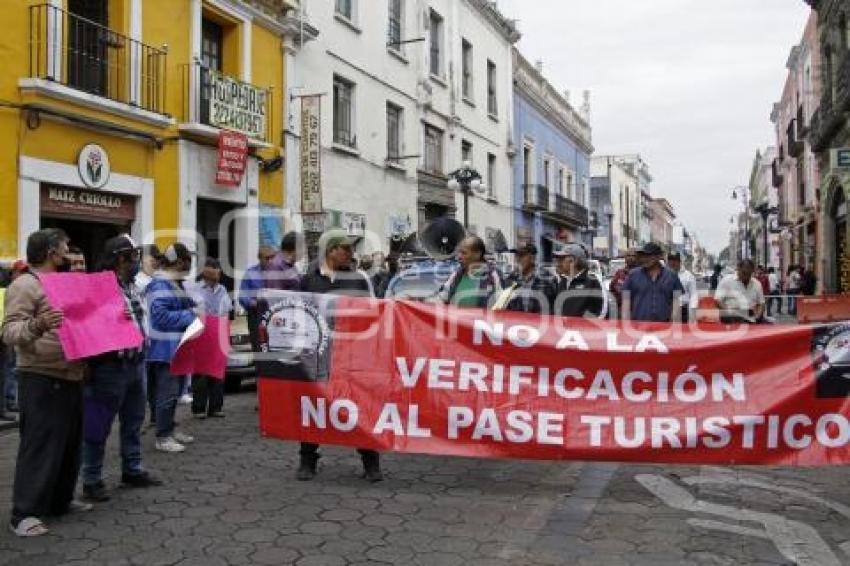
left=257, top=295, right=333, bottom=381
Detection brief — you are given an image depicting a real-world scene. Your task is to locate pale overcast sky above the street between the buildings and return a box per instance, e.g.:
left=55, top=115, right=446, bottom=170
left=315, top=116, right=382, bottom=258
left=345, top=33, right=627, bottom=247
left=498, top=0, right=809, bottom=253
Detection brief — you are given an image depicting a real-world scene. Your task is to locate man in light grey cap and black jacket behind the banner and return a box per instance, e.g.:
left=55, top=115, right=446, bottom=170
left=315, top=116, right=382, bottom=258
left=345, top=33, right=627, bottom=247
left=553, top=243, right=605, bottom=318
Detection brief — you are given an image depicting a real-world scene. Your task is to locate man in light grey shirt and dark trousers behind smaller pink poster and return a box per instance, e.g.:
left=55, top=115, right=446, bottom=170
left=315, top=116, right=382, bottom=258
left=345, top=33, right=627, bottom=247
left=189, top=258, right=233, bottom=419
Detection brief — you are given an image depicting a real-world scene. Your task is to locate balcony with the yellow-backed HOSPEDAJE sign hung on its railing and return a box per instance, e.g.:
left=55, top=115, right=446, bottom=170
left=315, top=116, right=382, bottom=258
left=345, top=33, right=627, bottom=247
left=181, top=63, right=273, bottom=146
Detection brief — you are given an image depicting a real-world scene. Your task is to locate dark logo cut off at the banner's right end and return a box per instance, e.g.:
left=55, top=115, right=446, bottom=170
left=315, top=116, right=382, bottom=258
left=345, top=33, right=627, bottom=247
left=812, top=324, right=850, bottom=399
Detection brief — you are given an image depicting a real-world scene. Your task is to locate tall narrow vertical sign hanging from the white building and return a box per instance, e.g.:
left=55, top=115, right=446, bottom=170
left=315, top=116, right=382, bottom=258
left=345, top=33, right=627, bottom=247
left=301, top=96, right=322, bottom=214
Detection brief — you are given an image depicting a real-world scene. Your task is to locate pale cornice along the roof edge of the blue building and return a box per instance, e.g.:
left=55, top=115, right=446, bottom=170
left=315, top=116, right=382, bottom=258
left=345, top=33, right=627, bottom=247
left=513, top=49, right=594, bottom=153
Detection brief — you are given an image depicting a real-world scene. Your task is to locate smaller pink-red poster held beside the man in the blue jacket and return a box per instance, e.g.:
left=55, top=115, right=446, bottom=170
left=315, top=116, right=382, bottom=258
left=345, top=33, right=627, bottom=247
left=171, top=315, right=230, bottom=379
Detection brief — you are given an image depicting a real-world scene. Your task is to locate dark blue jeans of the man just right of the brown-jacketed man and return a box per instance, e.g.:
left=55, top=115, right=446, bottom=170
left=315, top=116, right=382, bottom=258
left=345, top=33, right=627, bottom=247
left=82, top=361, right=145, bottom=485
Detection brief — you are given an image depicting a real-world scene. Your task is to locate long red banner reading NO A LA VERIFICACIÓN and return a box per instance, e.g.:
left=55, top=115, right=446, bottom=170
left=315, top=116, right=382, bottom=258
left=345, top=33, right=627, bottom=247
left=258, top=293, right=850, bottom=465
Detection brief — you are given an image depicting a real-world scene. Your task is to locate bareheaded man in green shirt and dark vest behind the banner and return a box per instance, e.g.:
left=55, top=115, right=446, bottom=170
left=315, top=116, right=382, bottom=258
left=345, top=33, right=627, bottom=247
left=439, top=236, right=502, bottom=308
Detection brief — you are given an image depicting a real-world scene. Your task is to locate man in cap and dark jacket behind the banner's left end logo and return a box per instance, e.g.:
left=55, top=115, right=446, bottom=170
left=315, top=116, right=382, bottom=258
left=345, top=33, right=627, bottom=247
left=296, top=232, right=384, bottom=482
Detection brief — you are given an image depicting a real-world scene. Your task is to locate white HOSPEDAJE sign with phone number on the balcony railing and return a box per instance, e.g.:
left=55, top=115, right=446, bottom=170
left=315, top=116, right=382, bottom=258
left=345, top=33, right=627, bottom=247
left=208, top=71, right=268, bottom=139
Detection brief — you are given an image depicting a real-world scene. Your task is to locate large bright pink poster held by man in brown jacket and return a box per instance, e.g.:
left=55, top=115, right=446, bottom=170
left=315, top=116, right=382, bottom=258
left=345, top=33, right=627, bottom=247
left=39, top=271, right=144, bottom=361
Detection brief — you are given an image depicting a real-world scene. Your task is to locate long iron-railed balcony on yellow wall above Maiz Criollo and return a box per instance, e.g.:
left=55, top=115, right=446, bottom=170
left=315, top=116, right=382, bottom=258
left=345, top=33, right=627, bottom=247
left=21, top=4, right=168, bottom=117
